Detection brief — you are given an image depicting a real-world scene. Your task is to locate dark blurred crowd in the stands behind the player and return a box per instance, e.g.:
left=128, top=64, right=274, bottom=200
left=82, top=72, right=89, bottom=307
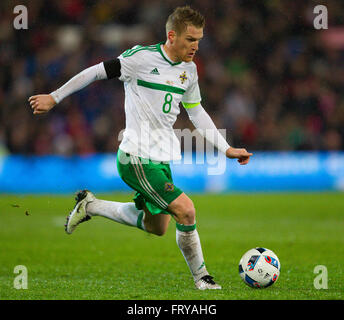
left=0, top=0, right=344, bottom=155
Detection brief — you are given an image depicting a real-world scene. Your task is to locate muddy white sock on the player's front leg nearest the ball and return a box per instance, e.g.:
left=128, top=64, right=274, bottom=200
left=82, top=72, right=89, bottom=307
left=176, top=225, right=209, bottom=282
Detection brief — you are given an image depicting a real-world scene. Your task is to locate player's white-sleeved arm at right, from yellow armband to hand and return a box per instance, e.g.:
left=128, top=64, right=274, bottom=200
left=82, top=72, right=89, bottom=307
left=182, top=102, right=253, bottom=165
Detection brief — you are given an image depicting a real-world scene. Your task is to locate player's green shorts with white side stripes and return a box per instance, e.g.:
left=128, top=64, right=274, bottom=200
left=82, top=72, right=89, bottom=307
left=117, top=149, right=183, bottom=215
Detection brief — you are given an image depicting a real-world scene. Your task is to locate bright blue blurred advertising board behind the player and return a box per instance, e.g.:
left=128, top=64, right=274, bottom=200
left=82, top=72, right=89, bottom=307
left=0, top=152, right=344, bottom=193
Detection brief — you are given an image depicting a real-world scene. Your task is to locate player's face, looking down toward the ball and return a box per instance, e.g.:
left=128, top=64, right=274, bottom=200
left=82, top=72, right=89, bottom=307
left=173, top=25, right=203, bottom=62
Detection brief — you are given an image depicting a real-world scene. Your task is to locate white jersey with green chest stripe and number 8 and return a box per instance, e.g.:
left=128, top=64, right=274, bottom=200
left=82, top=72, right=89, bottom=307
left=118, top=43, right=201, bottom=161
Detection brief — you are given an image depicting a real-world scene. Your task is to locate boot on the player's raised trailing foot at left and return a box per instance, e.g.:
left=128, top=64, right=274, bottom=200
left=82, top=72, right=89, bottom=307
left=65, top=190, right=95, bottom=234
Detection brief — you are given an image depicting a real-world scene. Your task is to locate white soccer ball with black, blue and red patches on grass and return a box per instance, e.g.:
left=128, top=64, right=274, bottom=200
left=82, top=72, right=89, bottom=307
left=239, top=248, right=281, bottom=288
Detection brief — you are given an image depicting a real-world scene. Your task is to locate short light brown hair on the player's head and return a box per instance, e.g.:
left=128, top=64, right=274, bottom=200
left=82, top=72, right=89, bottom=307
left=166, top=6, right=205, bottom=35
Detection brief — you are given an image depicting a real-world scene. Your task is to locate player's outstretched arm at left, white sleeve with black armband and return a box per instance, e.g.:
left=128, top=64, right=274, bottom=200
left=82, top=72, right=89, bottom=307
left=29, top=59, right=121, bottom=114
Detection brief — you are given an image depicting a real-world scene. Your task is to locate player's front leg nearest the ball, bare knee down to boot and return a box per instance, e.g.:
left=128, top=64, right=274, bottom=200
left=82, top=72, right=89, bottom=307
left=168, top=193, right=221, bottom=290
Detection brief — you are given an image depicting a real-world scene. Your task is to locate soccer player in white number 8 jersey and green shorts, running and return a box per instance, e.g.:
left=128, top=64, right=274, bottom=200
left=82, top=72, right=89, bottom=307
left=29, top=6, right=252, bottom=290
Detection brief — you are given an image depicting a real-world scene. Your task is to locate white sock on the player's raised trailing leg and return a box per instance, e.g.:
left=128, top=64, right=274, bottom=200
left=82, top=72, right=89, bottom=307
left=86, top=199, right=145, bottom=230
